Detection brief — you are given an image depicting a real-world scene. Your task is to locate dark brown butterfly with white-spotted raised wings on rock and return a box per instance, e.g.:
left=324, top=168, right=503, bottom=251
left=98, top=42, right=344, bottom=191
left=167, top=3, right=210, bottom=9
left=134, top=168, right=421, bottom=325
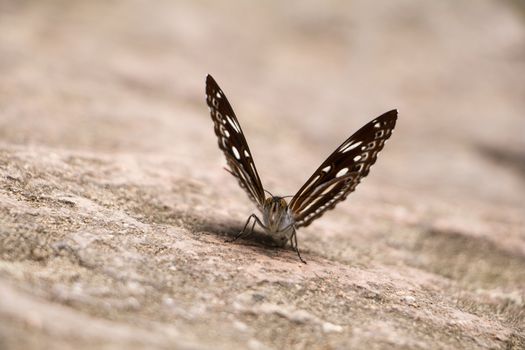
left=206, top=75, right=397, bottom=263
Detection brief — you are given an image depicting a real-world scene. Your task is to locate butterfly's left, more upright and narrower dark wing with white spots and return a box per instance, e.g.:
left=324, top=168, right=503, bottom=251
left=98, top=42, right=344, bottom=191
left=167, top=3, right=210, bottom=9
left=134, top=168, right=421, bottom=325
left=206, top=75, right=265, bottom=207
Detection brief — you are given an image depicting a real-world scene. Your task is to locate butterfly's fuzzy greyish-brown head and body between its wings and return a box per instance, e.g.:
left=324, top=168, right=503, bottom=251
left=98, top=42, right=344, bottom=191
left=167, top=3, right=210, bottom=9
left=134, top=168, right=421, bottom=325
left=262, top=196, right=294, bottom=238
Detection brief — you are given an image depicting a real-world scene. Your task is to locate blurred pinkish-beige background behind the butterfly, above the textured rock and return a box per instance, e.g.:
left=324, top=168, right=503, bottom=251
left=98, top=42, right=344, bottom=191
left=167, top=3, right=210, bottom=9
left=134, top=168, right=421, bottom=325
left=0, top=0, right=525, bottom=205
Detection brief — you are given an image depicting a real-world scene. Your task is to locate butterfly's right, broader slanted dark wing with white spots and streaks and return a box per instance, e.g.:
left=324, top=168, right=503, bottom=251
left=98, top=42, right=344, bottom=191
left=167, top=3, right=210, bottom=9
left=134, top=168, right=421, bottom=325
left=289, top=110, right=397, bottom=227
